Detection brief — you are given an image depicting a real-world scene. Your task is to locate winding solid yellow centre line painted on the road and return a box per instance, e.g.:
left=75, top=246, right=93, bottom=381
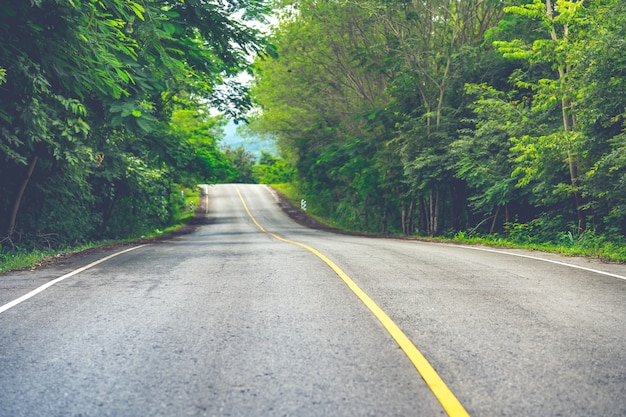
left=234, top=186, right=469, bottom=417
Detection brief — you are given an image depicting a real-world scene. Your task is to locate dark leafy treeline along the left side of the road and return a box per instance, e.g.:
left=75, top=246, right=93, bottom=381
left=0, top=0, right=267, bottom=247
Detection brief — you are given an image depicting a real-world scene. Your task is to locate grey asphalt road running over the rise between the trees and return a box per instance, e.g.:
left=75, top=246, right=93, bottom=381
left=0, top=185, right=626, bottom=417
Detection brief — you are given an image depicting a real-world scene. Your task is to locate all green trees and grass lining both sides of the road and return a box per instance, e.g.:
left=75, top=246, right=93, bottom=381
left=0, top=0, right=626, bottom=271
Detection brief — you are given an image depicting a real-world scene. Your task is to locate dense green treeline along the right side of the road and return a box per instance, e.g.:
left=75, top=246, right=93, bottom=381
left=253, top=0, right=626, bottom=241
